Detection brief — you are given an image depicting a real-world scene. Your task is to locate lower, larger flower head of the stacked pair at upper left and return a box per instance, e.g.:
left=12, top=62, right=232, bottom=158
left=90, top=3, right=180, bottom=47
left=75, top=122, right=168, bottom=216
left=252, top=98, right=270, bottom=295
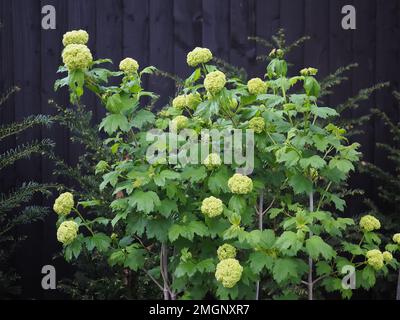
left=62, top=44, right=93, bottom=70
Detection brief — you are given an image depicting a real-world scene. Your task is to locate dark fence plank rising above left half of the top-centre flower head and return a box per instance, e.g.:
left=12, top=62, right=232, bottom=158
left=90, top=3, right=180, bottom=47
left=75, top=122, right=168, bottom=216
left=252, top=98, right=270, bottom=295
left=174, top=0, right=202, bottom=78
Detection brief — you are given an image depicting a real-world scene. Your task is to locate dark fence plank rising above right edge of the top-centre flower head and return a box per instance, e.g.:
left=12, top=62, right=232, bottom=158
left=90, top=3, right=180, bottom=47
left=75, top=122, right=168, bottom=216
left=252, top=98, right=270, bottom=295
left=203, top=0, right=231, bottom=62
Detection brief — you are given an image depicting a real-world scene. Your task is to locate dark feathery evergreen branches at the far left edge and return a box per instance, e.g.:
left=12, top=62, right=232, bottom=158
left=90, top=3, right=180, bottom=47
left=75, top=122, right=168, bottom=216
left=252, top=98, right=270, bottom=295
left=0, top=87, right=53, bottom=299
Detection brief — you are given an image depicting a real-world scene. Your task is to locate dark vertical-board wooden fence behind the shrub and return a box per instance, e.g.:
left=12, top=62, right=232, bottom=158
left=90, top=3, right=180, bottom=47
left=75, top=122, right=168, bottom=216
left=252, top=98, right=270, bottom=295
left=0, top=0, right=400, bottom=298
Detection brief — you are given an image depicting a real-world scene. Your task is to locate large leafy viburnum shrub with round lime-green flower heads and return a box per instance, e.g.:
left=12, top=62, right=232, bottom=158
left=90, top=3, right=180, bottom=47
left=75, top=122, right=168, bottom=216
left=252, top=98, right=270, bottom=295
left=54, top=31, right=398, bottom=299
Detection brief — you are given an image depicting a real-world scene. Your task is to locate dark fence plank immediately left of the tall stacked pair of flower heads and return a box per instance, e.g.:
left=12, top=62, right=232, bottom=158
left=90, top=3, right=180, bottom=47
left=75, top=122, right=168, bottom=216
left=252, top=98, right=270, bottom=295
left=39, top=0, right=70, bottom=299
